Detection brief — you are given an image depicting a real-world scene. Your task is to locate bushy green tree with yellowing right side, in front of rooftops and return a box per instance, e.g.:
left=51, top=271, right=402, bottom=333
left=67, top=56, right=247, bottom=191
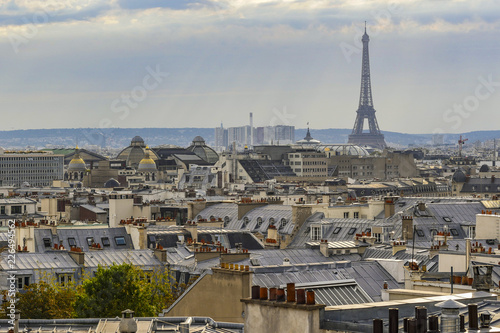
left=75, top=263, right=173, bottom=318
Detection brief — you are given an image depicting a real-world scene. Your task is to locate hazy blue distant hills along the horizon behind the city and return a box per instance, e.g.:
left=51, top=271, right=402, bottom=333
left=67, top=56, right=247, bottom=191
left=0, top=128, right=500, bottom=148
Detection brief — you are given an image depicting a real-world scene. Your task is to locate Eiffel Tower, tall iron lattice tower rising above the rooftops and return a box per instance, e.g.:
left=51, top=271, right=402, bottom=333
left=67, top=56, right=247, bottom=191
left=348, top=22, right=386, bottom=149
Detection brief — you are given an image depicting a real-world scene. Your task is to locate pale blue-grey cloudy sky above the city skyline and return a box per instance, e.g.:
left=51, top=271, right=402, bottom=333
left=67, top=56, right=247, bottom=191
left=0, top=0, right=500, bottom=133
